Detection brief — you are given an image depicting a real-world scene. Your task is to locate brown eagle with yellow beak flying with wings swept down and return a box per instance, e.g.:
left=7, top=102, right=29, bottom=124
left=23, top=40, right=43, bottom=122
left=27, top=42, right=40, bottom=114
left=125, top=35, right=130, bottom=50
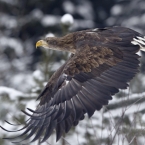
left=3, top=27, right=145, bottom=142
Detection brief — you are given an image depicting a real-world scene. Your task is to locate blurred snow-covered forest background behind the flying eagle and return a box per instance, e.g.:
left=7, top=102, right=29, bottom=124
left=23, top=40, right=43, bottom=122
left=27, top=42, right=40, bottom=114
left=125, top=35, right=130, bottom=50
left=0, top=0, right=145, bottom=145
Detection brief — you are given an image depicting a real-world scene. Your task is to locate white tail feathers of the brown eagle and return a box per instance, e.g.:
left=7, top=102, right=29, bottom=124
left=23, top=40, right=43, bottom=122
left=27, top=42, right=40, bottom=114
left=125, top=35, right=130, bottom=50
left=131, top=36, right=145, bottom=51
